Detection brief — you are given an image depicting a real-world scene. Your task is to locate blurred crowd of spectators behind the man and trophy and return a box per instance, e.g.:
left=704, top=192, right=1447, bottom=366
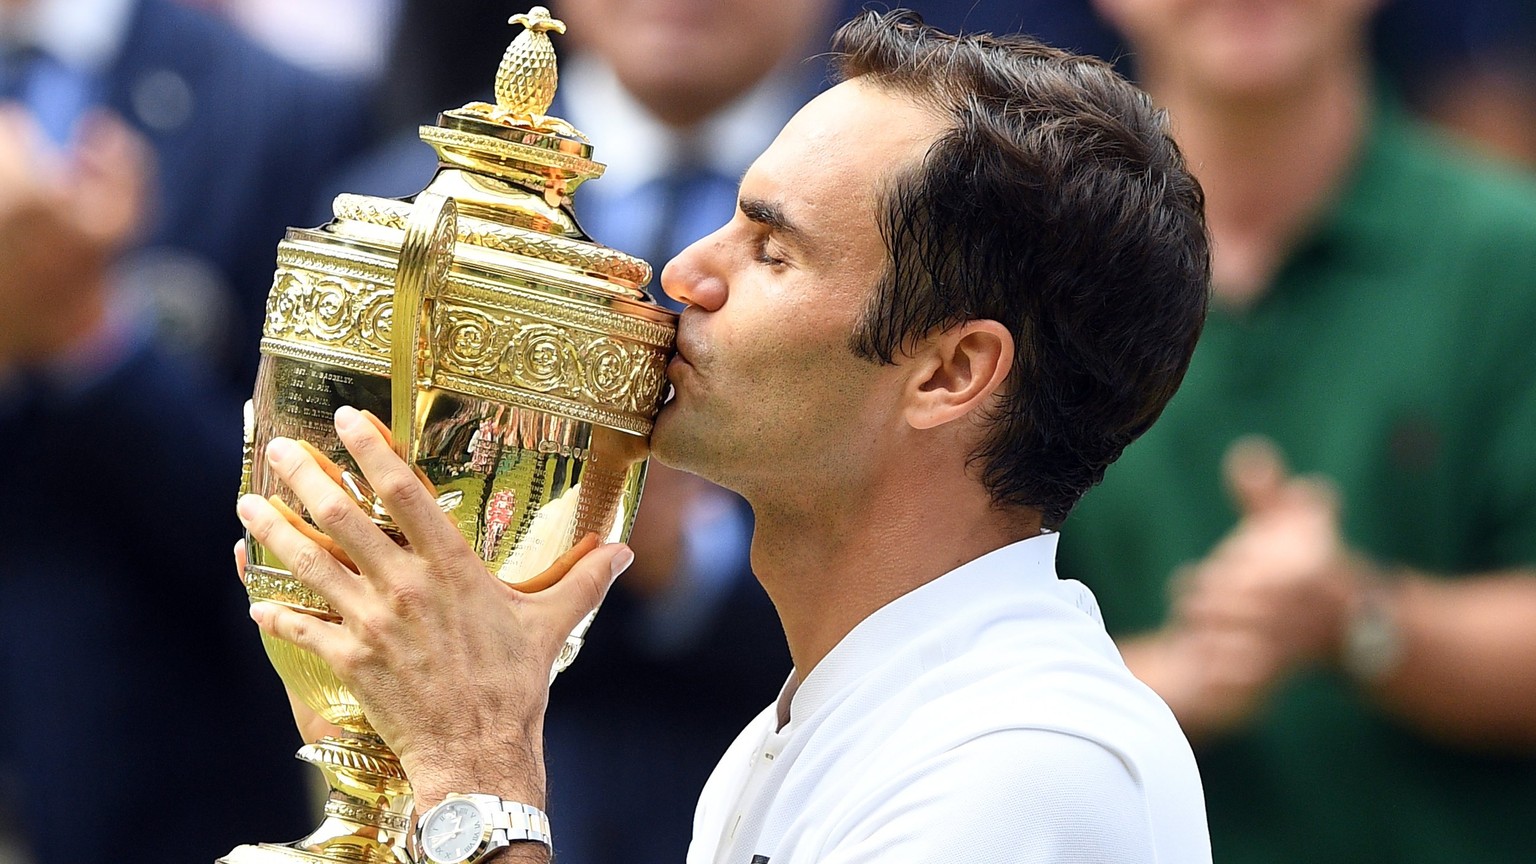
left=0, top=0, right=1536, bottom=864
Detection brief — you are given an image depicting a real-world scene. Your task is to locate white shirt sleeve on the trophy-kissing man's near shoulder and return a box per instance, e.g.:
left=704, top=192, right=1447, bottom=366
left=811, top=730, right=1155, bottom=864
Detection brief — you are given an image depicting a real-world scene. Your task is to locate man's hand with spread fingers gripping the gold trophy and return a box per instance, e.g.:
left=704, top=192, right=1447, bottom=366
left=238, top=407, right=633, bottom=807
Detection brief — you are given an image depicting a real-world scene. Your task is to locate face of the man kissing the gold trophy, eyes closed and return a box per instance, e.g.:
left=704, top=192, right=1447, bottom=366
left=653, top=78, right=942, bottom=500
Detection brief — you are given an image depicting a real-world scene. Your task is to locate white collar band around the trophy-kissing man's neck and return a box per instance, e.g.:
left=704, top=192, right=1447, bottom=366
left=777, top=532, right=1069, bottom=732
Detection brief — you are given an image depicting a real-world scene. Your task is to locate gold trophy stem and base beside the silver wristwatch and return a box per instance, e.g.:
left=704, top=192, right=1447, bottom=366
left=218, top=733, right=415, bottom=864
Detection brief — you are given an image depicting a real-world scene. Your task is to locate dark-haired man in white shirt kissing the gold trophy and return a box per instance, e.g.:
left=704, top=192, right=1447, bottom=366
left=240, top=14, right=1209, bottom=864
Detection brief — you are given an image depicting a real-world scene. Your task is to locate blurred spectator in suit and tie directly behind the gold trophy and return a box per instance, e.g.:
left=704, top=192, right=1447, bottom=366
left=317, top=0, right=831, bottom=864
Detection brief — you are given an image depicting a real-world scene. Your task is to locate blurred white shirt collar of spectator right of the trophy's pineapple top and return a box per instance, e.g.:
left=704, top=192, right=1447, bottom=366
left=559, top=54, right=806, bottom=197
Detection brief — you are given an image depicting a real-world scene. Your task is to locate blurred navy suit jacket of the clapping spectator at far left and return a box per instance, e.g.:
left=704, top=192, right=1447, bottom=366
left=0, top=0, right=359, bottom=864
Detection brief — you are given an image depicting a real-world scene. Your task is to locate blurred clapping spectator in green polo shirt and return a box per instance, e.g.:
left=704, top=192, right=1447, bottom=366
left=1061, top=0, right=1536, bottom=864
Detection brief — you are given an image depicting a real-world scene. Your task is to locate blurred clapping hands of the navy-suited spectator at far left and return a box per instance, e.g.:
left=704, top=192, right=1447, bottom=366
left=0, top=106, right=151, bottom=369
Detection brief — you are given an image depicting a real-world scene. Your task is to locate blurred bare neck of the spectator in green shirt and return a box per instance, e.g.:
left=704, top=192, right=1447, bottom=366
left=1143, top=54, right=1370, bottom=307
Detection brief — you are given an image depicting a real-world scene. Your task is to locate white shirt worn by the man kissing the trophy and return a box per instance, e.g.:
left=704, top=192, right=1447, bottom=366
left=688, top=533, right=1210, bottom=864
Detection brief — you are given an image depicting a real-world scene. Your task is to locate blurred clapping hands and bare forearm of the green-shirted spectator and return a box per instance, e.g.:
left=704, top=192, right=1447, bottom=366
left=1121, top=440, right=1536, bottom=753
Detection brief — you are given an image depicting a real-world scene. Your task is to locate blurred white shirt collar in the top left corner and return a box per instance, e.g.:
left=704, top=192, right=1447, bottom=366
left=0, top=0, right=135, bottom=74
